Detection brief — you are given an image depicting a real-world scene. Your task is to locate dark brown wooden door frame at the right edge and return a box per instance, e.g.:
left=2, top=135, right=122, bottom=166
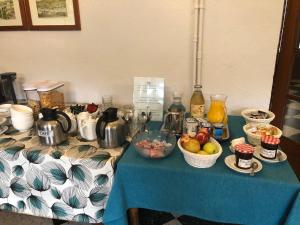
left=270, top=0, right=300, bottom=179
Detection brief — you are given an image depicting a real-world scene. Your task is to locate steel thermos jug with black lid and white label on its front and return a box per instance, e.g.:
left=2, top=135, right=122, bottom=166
left=37, top=108, right=72, bottom=145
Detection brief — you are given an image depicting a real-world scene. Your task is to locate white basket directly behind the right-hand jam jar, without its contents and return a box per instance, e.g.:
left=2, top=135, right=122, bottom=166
left=243, top=123, right=282, bottom=145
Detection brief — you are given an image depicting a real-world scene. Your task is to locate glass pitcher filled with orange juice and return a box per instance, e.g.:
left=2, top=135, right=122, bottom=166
left=207, top=94, right=227, bottom=126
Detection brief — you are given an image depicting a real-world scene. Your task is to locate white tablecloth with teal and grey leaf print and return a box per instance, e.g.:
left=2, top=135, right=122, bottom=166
left=0, top=126, right=123, bottom=223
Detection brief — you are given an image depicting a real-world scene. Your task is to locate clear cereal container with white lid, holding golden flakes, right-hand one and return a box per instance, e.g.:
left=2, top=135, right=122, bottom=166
left=37, top=81, right=65, bottom=110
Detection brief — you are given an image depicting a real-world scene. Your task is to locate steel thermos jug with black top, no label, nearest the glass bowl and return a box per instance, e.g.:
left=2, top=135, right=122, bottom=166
left=96, top=108, right=127, bottom=148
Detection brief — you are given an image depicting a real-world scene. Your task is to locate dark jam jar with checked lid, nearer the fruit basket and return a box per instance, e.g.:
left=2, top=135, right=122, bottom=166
left=234, top=144, right=254, bottom=169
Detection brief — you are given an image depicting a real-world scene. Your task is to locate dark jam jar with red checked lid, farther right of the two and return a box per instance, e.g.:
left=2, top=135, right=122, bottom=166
left=260, top=135, right=280, bottom=159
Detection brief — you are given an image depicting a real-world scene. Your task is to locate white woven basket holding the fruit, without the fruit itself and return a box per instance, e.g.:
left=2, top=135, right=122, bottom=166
left=177, top=138, right=223, bottom=168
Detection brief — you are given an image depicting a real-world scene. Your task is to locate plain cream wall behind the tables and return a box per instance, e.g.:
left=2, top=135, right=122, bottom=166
left=0, top=0, right=283, bottom=112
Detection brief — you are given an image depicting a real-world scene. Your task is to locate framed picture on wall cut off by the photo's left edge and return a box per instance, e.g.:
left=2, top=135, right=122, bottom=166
left=0, top=0, right=27, bottom=31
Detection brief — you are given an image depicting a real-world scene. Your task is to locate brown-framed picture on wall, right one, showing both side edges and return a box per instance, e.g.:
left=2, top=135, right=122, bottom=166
left=24, top=0, right=81, bottom=30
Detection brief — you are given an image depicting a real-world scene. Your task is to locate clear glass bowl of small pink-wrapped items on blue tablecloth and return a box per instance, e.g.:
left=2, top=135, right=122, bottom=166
left=132, top=130, right=176, bottom=159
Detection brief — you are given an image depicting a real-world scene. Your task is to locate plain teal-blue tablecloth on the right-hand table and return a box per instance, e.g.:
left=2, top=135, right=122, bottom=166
left=104, top=116, right=300, bottom=225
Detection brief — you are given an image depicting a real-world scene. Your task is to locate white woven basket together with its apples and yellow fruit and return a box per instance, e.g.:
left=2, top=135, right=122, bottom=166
left=178, top=128, right=223, bottom=168
